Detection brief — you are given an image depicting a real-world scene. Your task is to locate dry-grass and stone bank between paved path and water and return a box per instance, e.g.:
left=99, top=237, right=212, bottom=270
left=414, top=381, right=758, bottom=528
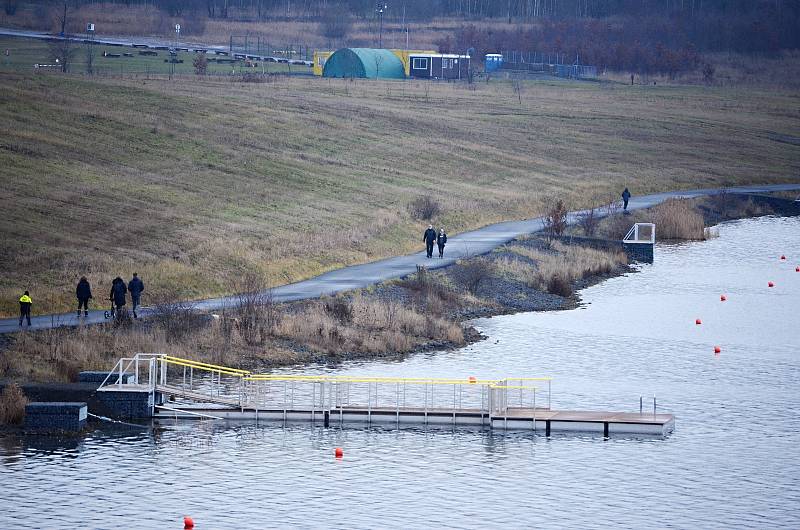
left=0, top=191, right=800, bottom=383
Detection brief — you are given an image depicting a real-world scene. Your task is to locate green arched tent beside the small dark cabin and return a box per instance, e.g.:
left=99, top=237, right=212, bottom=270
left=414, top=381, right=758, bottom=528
left=322, top=48, right=405, bottom=79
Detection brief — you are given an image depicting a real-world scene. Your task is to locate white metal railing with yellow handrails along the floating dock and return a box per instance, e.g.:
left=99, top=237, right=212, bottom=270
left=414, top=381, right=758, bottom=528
left=101, top=353, right=551, bottom=416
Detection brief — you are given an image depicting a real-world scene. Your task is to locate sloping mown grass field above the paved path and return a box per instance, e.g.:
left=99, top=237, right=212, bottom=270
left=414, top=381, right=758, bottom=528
left=0, top=36, right=800, bottom=315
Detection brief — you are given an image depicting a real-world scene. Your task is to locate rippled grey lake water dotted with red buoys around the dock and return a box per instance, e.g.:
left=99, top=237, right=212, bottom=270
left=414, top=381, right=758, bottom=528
left=0, top=218, right=800, bottom=529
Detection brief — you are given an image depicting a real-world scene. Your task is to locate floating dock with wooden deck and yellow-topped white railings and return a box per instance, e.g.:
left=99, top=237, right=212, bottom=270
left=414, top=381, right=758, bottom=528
left=98, top=353, right=675, bottom=436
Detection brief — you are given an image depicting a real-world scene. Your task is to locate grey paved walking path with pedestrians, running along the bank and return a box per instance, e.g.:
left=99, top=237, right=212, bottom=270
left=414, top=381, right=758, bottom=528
left=0, top=183, right=800, bottom=333
